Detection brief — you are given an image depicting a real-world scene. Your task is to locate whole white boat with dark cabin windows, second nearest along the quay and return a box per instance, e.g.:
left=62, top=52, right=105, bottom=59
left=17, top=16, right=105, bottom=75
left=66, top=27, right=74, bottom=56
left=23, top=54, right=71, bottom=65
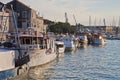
left=19, top=28, right=57, bottom=68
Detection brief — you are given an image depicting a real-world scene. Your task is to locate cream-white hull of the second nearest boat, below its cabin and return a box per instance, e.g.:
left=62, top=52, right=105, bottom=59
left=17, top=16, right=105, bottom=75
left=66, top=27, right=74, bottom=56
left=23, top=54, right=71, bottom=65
left=28, top=49, right=57, bottom=68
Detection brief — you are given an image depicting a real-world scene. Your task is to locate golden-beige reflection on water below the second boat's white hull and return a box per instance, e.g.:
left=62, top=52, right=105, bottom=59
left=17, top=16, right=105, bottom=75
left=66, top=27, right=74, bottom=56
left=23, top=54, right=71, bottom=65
left=27, top=57, right=63, bottom=80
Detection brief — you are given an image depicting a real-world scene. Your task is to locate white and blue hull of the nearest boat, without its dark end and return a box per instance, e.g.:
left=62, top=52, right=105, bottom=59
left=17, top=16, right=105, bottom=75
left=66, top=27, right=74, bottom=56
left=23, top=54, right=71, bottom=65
left=0, top=49, right=29, bottom=80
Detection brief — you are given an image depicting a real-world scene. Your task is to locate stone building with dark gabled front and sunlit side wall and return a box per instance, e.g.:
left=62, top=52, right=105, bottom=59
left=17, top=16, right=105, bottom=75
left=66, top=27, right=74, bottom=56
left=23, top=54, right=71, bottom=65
left=6, top=0, right=47, bottom=32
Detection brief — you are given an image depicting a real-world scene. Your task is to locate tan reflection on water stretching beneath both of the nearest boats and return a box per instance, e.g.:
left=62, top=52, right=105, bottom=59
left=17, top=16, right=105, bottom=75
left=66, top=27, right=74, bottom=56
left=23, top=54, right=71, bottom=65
left=9, top=60, right=56, bottom=80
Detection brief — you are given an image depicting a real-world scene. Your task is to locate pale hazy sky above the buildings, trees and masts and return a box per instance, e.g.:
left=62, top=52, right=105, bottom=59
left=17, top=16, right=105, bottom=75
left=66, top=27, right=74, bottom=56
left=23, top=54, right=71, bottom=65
left=0, top=0, right=120, bottom=25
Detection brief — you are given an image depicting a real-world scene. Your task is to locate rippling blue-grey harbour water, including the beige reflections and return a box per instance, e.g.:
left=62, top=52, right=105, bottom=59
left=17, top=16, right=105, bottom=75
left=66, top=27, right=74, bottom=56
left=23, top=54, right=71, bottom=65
left=12, top=40, right=120, bottom=80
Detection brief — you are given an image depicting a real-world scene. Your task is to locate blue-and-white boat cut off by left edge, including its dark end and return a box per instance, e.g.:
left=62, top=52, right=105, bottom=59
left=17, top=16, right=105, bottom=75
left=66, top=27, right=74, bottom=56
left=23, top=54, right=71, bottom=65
left=0, top=46, right=29, bottom=80
